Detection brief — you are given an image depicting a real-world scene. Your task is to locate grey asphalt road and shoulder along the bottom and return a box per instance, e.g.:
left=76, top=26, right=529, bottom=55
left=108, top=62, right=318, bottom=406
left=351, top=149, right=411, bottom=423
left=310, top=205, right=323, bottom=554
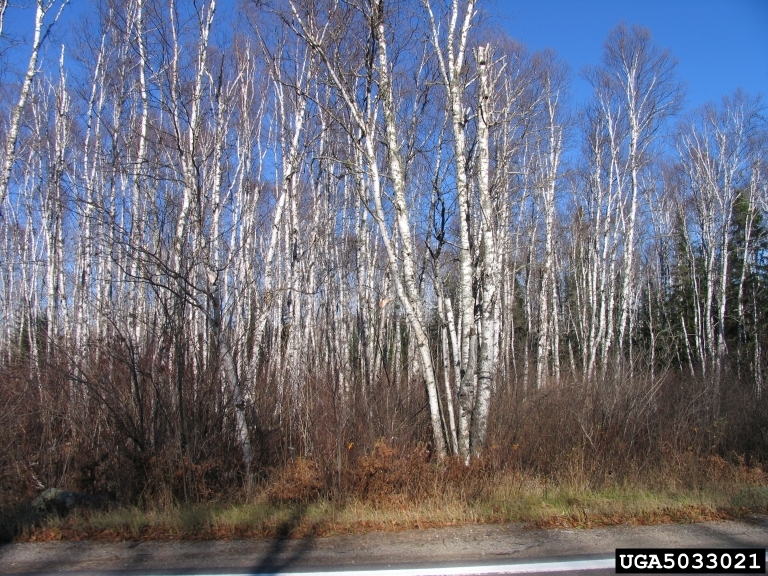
left=0, top=516, right=768, bottom=576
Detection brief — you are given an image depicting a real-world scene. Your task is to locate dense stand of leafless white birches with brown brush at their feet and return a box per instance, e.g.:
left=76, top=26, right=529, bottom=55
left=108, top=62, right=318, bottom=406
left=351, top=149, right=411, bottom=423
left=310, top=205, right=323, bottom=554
left=0, top=0, right=768, bottom=503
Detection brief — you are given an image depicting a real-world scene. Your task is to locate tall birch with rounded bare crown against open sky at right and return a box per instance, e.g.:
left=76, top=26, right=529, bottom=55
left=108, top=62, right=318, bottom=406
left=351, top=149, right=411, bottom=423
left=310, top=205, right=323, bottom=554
left=587, top=24, right=682, bottom=373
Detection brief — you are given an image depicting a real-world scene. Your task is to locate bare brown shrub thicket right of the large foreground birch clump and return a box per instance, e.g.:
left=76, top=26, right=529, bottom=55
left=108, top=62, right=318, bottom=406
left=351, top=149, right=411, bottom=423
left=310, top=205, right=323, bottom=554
left=490, top=371, right=767, bottom=487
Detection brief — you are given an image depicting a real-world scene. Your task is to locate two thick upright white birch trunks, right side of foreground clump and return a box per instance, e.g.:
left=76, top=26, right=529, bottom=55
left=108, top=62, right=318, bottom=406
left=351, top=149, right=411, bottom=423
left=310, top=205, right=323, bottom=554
left=422, top=0, right=530, bottom=462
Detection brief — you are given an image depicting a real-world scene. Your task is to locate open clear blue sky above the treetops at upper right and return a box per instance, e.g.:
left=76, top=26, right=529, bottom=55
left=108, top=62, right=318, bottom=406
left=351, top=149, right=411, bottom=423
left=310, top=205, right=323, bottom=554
left=488, top=0, right=768, bottom=108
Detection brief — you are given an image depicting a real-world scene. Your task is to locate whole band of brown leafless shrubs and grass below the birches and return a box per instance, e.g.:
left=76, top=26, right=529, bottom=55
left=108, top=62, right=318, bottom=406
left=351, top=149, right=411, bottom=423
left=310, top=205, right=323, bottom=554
left=0, top=358, right=768, bottom=541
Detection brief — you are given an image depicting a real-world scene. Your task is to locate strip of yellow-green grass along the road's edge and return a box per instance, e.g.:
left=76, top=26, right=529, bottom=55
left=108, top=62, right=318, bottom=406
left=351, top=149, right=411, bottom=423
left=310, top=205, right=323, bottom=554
left=16, top=461, right=768, bottom=541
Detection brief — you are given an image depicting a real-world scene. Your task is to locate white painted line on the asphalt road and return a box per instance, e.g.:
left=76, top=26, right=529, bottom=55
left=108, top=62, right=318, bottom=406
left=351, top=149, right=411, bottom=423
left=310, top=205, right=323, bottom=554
left=188, top=558, right=615, bottom=576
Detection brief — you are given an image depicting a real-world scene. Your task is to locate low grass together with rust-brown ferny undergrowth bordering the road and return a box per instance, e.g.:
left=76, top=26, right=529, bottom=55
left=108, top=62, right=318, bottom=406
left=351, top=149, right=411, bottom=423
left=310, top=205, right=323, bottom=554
left=7, top=441, right=768, bottom=542
